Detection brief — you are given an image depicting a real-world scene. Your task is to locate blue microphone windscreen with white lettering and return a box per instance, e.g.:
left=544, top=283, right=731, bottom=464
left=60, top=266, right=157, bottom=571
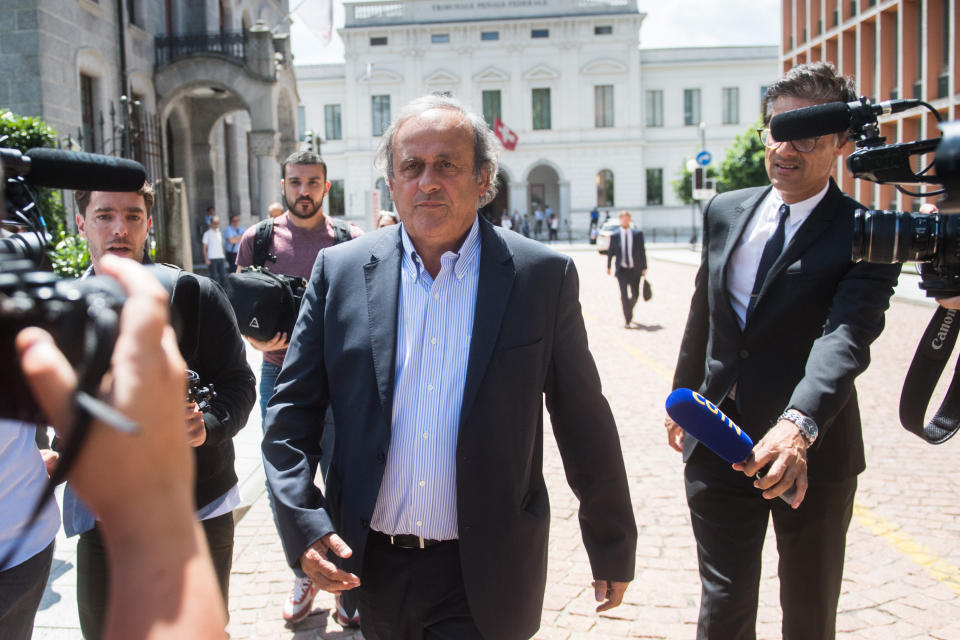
left=667, top=389, right=753, bottom=464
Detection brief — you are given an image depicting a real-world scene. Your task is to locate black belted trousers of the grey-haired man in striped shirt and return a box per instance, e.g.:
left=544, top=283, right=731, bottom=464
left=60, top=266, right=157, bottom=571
left=357, top=531, right=483, bottom=640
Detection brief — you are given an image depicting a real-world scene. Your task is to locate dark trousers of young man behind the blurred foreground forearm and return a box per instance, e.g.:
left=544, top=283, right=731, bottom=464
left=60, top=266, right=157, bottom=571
left=77, top=513, right=234, bottom=640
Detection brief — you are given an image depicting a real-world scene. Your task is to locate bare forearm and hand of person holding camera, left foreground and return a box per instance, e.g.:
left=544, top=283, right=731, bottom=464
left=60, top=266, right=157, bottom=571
left=16, top=256, right=226, bottom=640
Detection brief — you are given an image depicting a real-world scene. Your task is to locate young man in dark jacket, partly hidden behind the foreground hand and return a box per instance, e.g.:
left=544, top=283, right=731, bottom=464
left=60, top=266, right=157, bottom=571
left=63, top=183, right=256, bottom=640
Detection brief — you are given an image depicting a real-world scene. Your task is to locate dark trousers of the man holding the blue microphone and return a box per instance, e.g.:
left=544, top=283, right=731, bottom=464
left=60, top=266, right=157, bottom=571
left=684, top=410, right=857, bottom=640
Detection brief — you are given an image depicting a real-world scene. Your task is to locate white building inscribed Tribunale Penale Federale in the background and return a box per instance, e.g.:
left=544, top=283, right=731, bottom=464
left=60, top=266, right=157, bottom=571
left=297, top=0, right=778, bottom=239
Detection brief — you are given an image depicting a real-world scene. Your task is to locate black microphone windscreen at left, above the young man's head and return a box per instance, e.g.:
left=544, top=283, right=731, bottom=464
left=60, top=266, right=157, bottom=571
left=24, top=148, right=147, bottom=191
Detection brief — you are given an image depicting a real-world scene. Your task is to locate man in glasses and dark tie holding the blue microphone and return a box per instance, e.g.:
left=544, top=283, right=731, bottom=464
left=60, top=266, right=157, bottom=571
left=666, top=63, right=899, bottom=640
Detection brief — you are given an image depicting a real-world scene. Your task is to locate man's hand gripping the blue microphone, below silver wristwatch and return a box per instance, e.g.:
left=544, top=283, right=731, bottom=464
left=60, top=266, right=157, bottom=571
left=733, top=420, right=808, bottom=509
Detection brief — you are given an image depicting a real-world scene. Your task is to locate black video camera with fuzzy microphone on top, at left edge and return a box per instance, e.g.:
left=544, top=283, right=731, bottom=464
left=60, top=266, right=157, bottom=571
left=0, top=146, right=146, bottom=423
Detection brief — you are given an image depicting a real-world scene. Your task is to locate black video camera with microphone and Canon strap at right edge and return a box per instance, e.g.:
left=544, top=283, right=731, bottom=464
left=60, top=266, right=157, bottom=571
left=770, top=97, right=960, bottom=444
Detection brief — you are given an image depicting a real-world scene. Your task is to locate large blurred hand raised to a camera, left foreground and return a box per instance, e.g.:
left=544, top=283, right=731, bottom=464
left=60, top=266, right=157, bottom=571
left=16, top=255, right=194, bottom=529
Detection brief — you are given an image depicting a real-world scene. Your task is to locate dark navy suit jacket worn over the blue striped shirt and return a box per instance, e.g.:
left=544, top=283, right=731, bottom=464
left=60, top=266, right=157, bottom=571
left=263, top=218, right=637, bottom=639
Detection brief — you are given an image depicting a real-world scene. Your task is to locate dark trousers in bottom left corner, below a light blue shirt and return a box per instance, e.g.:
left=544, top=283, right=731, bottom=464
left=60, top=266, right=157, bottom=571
left=0, top=542, right=53, bottom=640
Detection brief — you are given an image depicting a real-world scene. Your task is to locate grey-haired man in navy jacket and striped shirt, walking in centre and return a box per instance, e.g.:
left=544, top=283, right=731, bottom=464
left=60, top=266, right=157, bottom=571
left=263, top=95, right=637, bottom=640
